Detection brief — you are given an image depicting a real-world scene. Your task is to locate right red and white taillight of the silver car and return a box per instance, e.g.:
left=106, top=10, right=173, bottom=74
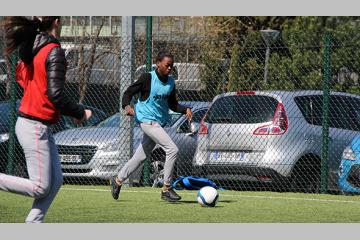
left=254, top=103, right=288, bottom=135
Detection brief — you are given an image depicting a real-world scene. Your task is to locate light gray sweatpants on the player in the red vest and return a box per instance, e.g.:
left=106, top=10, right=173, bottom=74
left=0, top=117, right=63, bottom=223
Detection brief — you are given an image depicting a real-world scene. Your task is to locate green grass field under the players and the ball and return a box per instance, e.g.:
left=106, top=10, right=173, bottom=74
left=0, top=185, right=360, bottom=223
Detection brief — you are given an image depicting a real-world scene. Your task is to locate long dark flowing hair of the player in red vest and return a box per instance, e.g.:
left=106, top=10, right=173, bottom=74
left=4, top=16, right=60, bottom=63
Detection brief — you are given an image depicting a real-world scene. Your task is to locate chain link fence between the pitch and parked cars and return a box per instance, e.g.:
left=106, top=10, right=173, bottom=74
left=0, top=29, right=360, bottom=192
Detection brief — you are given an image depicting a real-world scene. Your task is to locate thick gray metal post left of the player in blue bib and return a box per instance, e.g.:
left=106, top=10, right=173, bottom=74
left=119, top=16, right=135, bottom=186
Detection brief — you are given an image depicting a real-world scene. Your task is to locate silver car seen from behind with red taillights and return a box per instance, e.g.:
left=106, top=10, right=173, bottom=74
left=193, top=91, right=360, bottom=192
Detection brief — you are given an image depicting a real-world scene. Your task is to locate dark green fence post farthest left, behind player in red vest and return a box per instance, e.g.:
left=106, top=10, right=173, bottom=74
left=6, top=51, right=17, bottom=175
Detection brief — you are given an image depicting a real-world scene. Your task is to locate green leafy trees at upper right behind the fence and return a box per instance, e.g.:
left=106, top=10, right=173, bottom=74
left=201, top=17, right=360, bottom=92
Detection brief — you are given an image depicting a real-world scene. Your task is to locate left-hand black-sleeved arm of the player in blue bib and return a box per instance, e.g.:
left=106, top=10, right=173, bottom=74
left=121, top=73, right=151, bottom=109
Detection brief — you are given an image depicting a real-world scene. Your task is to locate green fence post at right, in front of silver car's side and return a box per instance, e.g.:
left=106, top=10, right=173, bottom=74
left=321, top=33, right=331, bottom=193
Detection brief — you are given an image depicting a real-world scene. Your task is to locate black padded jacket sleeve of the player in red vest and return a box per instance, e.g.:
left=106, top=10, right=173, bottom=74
left=46, top=47, right=86, bottom=120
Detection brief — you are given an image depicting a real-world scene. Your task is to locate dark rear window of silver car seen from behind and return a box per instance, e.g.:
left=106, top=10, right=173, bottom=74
left=205, top=95, right=278, bottom=124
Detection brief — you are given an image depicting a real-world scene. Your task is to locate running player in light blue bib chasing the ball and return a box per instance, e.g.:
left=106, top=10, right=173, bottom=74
left=110, top=52, right=192, bottom=202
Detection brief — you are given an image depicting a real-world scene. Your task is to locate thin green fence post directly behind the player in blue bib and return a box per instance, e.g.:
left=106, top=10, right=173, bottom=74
left=144, top=16, right=152, bottom=186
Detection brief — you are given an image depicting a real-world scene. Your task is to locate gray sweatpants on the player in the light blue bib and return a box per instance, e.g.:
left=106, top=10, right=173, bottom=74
left=118, top=122, right=178, bottom=184
